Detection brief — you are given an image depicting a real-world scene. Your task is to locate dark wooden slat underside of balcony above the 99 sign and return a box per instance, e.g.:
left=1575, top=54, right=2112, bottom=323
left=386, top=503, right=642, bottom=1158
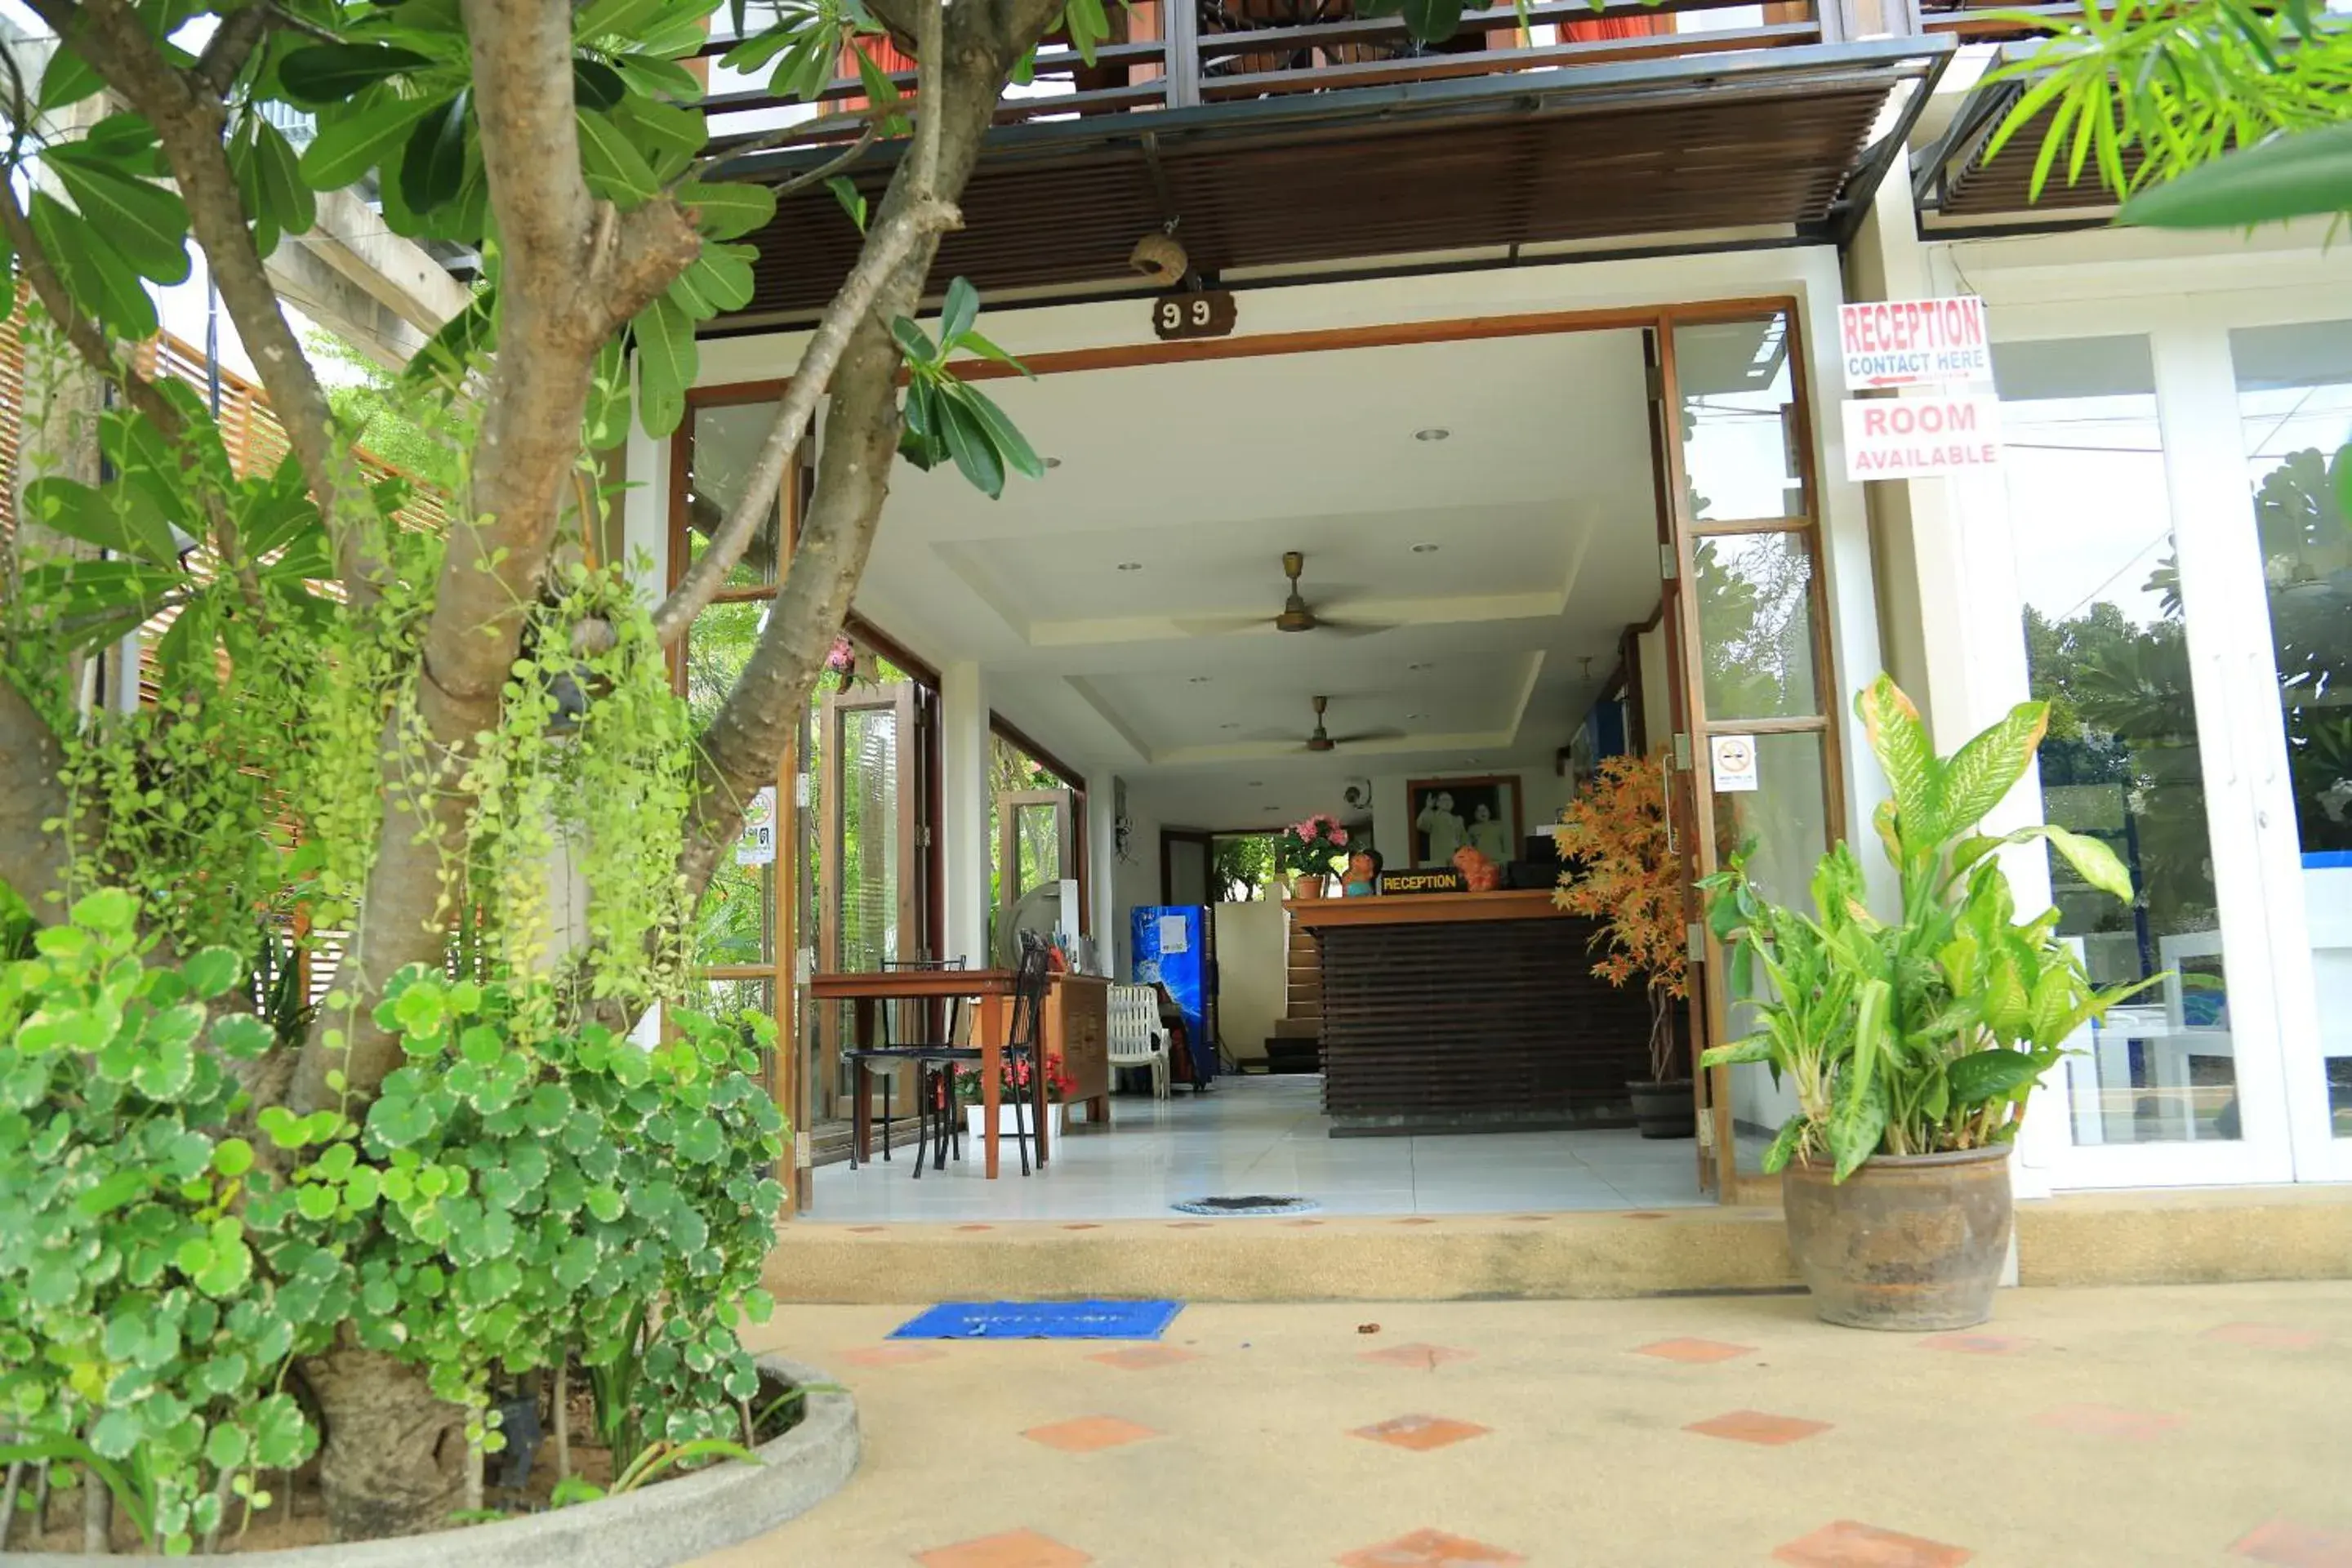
left=734, top=51, right=1928, bottom=327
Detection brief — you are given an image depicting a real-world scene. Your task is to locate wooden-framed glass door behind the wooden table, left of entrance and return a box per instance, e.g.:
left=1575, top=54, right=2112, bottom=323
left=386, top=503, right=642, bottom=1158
left=816, top=682, right=929, bottom=1114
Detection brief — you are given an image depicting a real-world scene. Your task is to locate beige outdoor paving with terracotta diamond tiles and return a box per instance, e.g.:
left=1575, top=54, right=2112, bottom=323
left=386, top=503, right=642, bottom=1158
left=703, top=1284, right=2352, bottom=1568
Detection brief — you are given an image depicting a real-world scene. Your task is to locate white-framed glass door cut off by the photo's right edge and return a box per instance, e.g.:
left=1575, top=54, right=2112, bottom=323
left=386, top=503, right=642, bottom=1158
left=2230, top=319, right=2352, bottom=1180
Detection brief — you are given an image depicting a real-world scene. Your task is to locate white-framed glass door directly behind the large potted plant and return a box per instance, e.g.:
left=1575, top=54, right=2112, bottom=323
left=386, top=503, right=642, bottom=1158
left=1976, top=329, right=2291, bottom=1187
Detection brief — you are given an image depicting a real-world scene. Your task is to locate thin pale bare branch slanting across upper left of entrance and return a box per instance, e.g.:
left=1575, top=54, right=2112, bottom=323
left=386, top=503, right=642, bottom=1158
left=654, top=188, right=957, bottom=647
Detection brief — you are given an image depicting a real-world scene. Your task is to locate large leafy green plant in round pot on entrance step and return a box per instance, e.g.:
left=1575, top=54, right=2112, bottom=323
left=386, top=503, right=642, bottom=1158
left=1700, top=675, right=2162, bottom=1330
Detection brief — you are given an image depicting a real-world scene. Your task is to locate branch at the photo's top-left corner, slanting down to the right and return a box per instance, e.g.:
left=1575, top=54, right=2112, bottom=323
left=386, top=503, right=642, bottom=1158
left=30, top=0, right=388, bottom=604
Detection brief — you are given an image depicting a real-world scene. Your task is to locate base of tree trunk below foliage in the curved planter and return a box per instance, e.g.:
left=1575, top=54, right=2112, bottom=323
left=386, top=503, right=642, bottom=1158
left=301, top=1340, right=466, bottom=1539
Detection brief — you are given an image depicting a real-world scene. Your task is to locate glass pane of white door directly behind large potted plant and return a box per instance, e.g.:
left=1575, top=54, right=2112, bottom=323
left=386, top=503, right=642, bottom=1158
left=1992, top=336, right=2239, bottom=1145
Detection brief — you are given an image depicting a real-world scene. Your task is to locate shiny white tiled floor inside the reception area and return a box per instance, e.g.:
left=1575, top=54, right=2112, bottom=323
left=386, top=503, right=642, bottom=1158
left=809, top=1076, right=1710, bottom=1223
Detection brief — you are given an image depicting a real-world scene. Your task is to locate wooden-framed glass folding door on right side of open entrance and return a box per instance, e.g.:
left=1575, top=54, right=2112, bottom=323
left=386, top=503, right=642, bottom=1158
left=1658, top=308, right=1844, bottom=1201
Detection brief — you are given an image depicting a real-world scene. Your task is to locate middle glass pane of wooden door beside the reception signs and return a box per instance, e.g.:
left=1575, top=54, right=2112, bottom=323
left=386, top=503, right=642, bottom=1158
left=1691, top=533, right=1820, bottom=724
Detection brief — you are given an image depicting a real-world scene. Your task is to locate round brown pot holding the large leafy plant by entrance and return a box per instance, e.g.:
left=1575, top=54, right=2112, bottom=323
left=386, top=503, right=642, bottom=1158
left=1780, top=1145, right=2011, bottom=1333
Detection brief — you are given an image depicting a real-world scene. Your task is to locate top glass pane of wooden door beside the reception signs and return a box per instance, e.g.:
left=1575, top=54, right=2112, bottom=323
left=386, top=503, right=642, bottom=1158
left=1675, top=315, right=1806, bottom=522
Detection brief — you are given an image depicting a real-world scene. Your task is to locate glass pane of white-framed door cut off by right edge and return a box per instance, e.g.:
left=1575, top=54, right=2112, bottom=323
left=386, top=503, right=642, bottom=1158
left=2230, top=322, right=2352, bottom=1138
